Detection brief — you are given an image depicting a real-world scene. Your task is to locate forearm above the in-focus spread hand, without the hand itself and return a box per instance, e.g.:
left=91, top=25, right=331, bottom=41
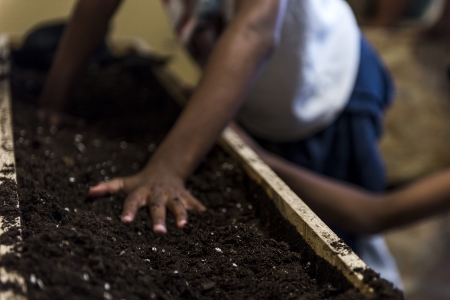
left=150, top=0, right=288, bottom=178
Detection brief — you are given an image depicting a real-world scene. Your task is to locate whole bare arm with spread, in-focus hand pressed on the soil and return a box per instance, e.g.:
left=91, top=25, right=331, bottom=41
left=90, top=0, right=286, bottom=233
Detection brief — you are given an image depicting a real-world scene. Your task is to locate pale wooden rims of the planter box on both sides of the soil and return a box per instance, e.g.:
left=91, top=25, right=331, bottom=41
left=0, top=36, right=398, bottom=300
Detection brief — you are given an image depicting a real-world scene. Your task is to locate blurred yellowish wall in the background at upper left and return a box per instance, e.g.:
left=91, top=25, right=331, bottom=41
left=0, top=0, right=200, bottom=85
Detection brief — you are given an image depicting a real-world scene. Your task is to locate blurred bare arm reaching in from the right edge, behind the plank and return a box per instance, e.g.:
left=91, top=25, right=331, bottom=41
left=235, top=122, right=450, bottom=234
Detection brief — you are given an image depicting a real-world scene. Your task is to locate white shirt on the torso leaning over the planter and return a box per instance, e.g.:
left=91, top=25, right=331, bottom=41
left=238, top=0, right=360, bottom=142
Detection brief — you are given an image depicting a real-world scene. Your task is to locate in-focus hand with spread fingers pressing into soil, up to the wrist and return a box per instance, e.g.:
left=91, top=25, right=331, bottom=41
left=89, top=167, right=206, bottom=234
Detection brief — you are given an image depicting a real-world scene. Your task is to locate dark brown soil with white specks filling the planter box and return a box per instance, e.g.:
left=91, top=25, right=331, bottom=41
left=0, top=61, right=403, bottom=299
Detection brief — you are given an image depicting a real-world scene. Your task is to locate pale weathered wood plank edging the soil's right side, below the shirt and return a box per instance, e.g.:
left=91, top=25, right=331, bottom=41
left=220, top=128, right=373, bottom=297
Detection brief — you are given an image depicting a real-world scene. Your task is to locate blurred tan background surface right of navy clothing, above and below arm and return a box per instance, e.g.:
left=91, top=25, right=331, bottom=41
left=365, top=29, right=450, bottom=300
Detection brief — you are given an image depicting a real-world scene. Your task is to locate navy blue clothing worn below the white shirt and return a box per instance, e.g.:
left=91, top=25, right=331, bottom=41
left=250, top=38, right=393, bottom=252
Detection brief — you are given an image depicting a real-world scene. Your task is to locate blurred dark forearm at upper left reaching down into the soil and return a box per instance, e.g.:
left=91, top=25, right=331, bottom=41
left=39, top=0, right=121, bottom=110
